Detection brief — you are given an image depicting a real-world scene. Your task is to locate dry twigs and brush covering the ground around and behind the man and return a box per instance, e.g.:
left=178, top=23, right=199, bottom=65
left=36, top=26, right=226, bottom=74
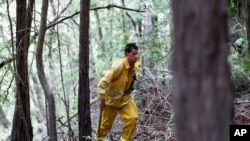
left=91, top=69, right=250, bottom=141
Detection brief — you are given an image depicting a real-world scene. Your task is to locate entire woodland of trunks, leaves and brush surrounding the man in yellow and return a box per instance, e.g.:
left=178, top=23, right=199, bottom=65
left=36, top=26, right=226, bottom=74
left=0, top=0, right=250, bottom=141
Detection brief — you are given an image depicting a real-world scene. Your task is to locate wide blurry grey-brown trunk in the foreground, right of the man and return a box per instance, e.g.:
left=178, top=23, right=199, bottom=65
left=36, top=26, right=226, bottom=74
left=172, top=0, right=233, bottom=141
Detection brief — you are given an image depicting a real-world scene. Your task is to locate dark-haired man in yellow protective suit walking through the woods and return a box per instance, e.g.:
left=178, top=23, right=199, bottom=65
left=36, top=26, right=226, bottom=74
left=97, top=43, right=140, bottom=141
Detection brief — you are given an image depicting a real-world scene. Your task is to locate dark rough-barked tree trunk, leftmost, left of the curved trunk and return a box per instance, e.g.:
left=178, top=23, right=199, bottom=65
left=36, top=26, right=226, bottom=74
left=11, top=0, right=34, bottom=141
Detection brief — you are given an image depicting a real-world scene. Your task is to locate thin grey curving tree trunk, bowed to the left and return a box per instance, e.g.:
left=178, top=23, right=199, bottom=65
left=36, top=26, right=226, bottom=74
left=36, top=0, right=57, bottom=141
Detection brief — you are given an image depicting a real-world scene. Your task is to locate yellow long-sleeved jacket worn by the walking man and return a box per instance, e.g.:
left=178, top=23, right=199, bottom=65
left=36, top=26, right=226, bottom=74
left=97, top=57, right=140, bottom=108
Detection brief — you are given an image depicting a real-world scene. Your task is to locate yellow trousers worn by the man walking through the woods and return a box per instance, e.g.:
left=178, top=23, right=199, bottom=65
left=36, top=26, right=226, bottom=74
left=97, top=99, right=138, bottom=141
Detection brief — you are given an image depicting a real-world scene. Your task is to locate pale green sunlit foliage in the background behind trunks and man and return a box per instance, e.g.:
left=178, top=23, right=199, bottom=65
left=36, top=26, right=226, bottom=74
left=0, top=0, right=250, bottom=140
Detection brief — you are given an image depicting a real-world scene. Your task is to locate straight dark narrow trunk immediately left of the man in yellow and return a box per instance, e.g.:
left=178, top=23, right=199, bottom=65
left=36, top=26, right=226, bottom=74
left=78, top=0, right=91, bottom=141
